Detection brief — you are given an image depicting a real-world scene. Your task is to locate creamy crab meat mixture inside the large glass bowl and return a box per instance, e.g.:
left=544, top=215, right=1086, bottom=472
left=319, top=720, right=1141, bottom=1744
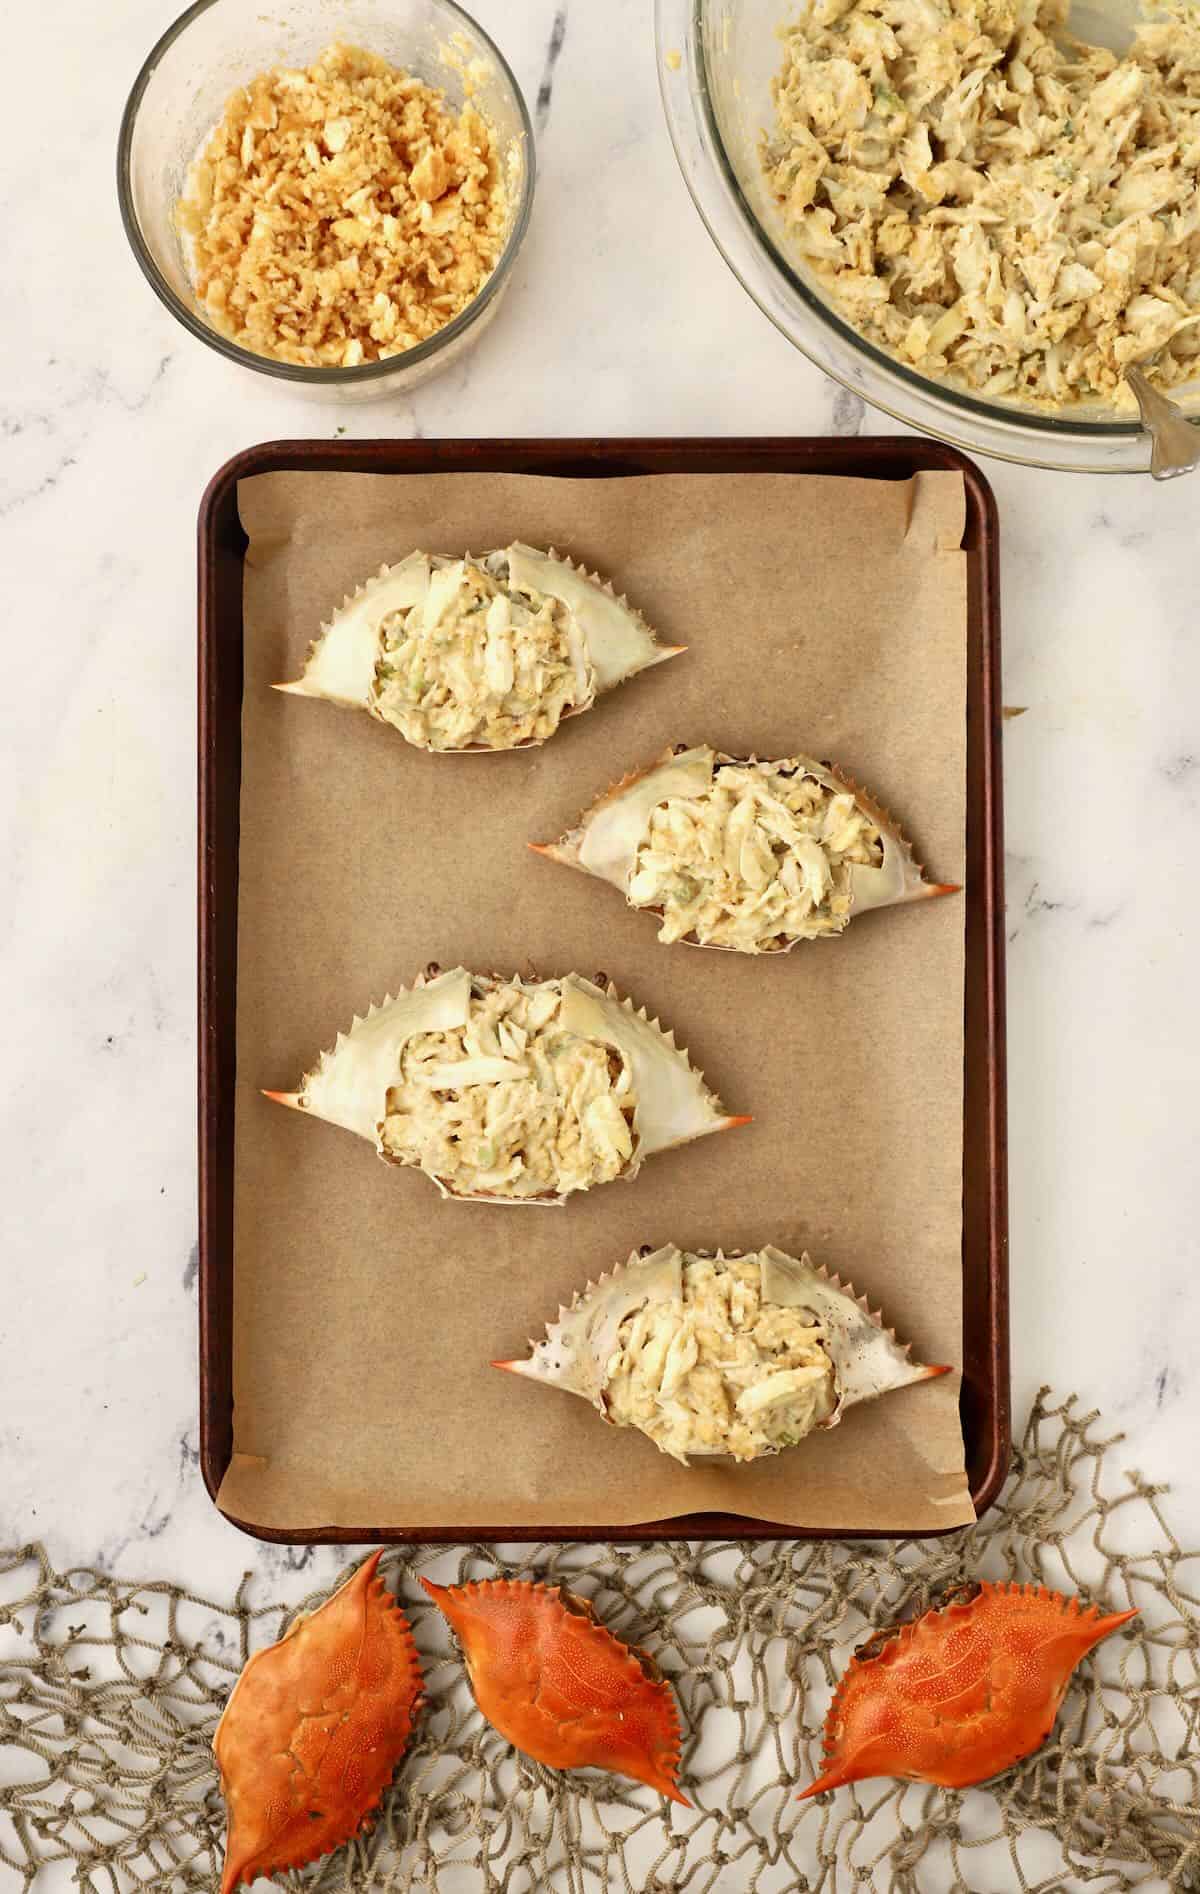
left=763, top=0, right=1200, bottom=409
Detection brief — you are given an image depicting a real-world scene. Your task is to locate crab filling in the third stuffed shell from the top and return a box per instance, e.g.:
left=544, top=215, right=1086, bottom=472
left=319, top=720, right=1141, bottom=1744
left=380, top=983, right=636, bottom=1197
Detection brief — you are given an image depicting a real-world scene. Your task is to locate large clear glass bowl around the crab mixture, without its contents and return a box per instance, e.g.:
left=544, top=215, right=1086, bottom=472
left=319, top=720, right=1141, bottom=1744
left=655, top=0, right=1200, bottom=474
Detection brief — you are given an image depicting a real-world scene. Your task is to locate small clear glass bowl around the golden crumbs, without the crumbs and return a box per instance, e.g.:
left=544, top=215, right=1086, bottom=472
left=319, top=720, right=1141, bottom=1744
left=117, top=0, right=536, bottom=400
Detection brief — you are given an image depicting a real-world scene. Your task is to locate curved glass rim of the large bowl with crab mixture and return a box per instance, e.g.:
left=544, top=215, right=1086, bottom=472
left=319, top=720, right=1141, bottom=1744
left=655, top=0, right=1200, bottom=462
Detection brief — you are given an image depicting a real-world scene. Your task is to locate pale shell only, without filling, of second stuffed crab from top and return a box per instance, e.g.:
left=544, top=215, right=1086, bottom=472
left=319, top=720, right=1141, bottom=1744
left=530, top=744, right=958, bottom=953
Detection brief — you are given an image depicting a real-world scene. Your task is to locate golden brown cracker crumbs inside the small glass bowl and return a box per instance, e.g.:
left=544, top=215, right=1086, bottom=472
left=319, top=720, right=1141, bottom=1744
left=178, top=45, right=509, bottom=367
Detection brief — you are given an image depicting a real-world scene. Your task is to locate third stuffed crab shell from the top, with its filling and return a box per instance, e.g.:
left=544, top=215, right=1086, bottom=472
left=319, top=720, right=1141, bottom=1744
left=267, top=968, right=748, bottom=1203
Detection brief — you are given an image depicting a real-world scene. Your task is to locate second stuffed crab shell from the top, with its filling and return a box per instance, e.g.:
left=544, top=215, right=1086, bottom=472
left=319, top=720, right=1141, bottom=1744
left=534, top=744, right=954, bottom=953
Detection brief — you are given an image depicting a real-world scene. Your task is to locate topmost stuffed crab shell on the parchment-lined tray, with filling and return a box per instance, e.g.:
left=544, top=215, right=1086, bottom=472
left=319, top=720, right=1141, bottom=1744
left=276, top=542, right=683, bottom=750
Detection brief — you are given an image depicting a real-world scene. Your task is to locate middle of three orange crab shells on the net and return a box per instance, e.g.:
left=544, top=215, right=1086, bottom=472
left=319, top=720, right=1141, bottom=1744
left=420, top=1578, right=691, bottom=1809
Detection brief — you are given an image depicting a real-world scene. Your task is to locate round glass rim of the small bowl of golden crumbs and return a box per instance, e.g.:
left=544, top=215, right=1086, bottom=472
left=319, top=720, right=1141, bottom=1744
left=117, top=0, right=538, bottom=388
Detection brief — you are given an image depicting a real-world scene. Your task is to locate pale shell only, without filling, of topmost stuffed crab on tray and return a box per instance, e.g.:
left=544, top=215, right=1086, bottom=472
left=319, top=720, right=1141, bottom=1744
left=274, top=540, right=685, bottom=754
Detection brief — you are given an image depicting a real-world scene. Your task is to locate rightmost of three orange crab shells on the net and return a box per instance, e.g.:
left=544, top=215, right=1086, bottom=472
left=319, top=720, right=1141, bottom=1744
left=801, top=1583, right=1138, bottom=1801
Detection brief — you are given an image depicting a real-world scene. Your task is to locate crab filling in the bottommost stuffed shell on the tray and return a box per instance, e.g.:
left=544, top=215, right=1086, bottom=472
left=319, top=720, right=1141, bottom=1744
left=604, top=1258, right=837, bottom=1460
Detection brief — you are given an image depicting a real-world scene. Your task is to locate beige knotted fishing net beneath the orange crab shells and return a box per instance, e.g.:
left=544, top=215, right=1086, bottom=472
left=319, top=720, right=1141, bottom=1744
left=0, top=1390, right=1200, bottom=1894
